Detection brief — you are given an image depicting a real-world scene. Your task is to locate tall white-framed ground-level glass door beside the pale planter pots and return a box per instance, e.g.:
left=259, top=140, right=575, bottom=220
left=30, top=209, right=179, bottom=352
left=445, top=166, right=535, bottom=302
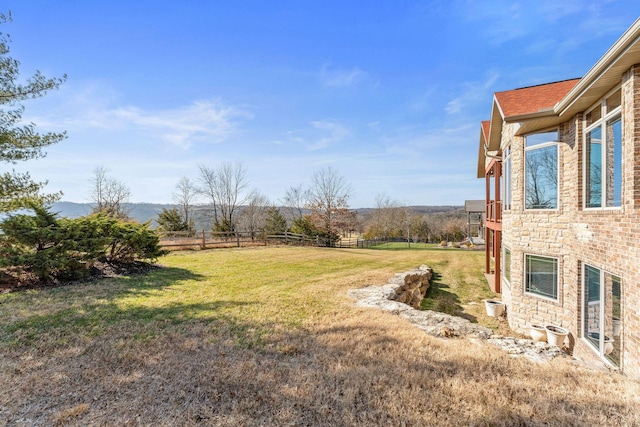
left=582, top=264, right=622, bottom=366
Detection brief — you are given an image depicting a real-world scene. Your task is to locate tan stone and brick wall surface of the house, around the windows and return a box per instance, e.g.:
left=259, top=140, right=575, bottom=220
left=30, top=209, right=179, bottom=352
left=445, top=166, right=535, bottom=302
left=502, top=65, right=640, bottom=377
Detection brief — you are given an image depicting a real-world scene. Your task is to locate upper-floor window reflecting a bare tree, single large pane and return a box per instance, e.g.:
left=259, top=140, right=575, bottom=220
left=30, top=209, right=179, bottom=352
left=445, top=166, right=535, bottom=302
left=524, top=131, right=558, bottom=209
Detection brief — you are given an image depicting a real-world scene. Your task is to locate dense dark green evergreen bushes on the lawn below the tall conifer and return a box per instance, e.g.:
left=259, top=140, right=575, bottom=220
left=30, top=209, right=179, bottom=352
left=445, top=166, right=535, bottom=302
left=0, top=206, right=164, bottom=281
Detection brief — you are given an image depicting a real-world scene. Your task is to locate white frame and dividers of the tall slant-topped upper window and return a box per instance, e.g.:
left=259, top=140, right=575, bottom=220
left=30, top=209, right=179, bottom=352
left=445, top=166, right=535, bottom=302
left=582, top=85, right=624, bottom=211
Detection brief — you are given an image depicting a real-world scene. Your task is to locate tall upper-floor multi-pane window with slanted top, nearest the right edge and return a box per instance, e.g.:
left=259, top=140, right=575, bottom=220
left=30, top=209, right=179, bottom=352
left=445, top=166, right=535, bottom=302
left=584, top=89, right=622, bottom=208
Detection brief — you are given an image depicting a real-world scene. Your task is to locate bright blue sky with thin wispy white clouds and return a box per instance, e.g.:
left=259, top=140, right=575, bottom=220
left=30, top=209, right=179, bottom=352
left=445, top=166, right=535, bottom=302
left=0, top=0, right=640, bottom=208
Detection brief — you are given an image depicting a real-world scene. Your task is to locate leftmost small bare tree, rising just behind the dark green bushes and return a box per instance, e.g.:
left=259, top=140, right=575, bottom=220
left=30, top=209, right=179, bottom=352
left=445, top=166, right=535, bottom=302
left=90, top=166, right=131, bottom=218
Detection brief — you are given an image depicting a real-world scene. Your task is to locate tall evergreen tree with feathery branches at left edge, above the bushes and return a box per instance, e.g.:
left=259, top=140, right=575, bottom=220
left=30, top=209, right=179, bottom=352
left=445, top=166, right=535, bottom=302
left=0, top=13, right=66, bottom=212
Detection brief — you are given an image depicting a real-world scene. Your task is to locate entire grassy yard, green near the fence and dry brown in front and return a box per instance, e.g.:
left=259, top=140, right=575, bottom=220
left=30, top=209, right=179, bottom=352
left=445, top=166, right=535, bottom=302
left=0, top=247, right=640, bottom=426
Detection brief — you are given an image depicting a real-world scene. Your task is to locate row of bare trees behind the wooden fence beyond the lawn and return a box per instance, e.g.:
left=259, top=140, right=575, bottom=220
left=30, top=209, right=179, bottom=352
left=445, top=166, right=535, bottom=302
left=84, top=155, right=467, bottom=246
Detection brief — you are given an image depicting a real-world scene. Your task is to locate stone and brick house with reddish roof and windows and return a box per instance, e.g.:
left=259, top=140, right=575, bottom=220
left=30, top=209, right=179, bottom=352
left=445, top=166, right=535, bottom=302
left=478, top=19, right=640, bottom=378
